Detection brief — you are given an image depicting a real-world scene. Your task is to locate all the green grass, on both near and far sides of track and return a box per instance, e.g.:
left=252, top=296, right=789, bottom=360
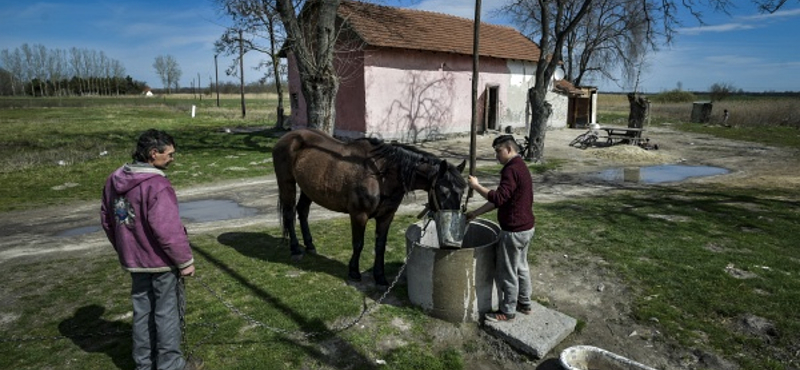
left=0, top=95, right=800, bottom=370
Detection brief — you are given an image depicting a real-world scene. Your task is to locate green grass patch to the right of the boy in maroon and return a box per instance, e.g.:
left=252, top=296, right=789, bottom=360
left=536, top=187, right=800, bottom=370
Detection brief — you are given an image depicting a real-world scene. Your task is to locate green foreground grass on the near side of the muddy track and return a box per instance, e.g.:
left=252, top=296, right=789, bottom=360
left=0, top=187, right=800, bottom=370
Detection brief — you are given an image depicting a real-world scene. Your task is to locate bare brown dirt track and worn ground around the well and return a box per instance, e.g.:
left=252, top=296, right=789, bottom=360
left=0, top=128, right=800, bottom=370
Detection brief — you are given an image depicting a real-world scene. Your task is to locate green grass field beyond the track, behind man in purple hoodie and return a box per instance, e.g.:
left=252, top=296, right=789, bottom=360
left=0, top=98, right=277, bottom=212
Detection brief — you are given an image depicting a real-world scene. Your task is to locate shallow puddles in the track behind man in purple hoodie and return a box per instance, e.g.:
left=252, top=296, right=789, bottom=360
left=56, top=199, right=258, bottom=237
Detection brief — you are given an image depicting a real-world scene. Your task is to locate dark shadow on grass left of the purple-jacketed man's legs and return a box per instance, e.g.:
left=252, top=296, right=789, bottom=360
left=58, top=304, right=134, bottom=369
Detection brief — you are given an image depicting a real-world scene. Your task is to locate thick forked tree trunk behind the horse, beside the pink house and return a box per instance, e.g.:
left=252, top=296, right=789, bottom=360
left=276, top=0, right=339, bottom=134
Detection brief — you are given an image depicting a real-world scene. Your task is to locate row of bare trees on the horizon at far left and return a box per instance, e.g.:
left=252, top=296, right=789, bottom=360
left=0, top=43, right=147, bottom=96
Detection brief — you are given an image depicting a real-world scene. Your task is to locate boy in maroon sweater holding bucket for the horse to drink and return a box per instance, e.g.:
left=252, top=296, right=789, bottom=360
left=466, top=135, right=536, bottom=321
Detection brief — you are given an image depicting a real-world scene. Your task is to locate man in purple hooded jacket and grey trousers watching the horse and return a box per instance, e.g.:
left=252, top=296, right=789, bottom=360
left=100, top=129, right=202, bottom=370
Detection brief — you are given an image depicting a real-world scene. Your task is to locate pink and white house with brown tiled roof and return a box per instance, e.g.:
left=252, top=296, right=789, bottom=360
left=288, top=0, right=575, bottom=142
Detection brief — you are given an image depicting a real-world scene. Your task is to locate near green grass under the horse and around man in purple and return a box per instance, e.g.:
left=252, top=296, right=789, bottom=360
left=0, top=216, right=463, bottom=369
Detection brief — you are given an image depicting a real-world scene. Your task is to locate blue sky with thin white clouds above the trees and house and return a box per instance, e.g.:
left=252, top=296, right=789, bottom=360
left=0, top=0, right=800, bottom=93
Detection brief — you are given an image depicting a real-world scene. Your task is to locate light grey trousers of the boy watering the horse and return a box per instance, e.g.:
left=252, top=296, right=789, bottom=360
left=495, top=229, right=535, bottom=314
